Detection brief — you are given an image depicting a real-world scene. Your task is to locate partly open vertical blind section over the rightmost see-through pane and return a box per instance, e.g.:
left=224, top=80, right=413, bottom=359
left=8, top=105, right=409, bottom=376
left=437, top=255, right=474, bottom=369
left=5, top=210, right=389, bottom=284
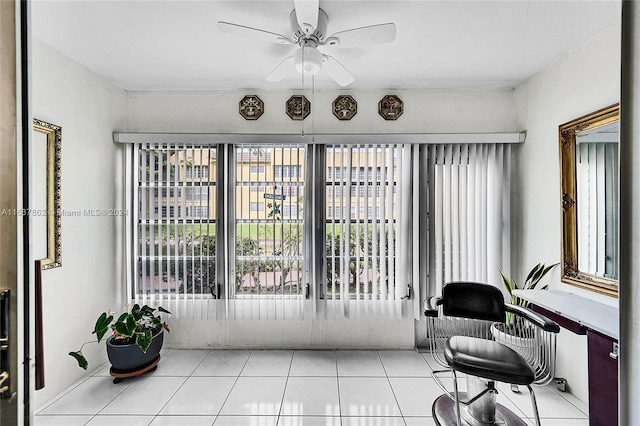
left=325, top=144, right=415, bottom=317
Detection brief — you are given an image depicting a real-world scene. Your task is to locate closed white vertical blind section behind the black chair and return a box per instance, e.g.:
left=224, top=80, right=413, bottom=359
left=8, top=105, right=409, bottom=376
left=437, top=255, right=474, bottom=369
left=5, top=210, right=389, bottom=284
left=425, top=144, right=511, bottom=294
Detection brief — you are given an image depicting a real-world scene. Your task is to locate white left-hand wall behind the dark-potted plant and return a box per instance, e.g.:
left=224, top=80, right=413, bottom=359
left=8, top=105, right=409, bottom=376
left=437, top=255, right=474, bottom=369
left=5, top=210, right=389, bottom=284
left=31, top=40, right=126, bottom=410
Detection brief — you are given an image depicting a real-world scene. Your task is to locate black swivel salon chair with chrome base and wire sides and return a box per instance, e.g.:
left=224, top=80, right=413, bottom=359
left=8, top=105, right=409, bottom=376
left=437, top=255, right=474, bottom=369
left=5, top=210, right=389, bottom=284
left=425, top=282, right=560, bottom=426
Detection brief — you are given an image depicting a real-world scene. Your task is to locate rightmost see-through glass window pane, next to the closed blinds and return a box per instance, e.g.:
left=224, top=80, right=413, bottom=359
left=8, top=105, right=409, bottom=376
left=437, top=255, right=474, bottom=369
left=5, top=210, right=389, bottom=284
left=326, top=145, right=397, bottom=298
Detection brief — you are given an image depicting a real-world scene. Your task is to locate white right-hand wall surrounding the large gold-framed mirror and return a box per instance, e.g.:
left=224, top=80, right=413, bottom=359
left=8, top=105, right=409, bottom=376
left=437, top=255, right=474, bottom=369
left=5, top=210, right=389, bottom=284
left=512, top=24, right=620, bottom=402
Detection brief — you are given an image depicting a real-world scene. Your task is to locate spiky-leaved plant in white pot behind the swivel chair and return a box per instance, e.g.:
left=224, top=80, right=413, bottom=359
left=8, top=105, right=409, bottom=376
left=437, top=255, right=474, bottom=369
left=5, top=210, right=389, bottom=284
left=491, top=263, right=558, bottom=347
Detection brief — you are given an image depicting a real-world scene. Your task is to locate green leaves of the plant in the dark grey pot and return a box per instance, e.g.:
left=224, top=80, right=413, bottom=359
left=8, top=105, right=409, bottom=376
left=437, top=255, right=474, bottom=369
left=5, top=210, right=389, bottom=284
left=69, top=303, right=171, bottom=370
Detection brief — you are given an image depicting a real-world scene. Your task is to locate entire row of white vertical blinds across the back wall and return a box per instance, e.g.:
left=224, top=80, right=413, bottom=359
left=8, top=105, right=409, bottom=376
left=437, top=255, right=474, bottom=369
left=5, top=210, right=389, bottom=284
left=130, top=143, right=510, bottom=320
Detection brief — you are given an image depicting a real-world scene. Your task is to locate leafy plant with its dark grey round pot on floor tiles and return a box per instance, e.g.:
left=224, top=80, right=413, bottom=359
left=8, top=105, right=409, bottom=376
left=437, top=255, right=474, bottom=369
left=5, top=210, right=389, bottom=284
left=69, top=304, right=170, bottom=371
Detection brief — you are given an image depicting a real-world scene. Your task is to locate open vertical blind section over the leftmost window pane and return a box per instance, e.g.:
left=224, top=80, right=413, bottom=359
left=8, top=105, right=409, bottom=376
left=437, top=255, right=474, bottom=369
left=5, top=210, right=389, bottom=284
left=133, top=144, right=217, bottom=318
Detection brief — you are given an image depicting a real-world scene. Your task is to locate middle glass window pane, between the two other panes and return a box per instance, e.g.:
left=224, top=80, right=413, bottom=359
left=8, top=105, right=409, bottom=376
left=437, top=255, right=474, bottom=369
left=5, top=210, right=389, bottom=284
left=235, top=144, right=305, bottom=297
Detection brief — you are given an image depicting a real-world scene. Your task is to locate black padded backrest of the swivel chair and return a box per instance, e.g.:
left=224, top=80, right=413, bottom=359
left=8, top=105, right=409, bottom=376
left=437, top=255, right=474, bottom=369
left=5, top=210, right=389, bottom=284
left=441, top=281, right=506, bottom=322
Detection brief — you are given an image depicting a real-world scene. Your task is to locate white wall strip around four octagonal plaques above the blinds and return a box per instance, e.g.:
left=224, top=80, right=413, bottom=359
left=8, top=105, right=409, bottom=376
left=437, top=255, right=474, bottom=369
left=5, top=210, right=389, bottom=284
left=123, top=89, right=520, bottom=134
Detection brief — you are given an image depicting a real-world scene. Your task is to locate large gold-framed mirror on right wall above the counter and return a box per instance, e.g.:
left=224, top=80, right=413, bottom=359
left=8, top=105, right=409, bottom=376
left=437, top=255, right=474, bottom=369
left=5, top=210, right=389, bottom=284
left=559, top=104, right=620, bottom=297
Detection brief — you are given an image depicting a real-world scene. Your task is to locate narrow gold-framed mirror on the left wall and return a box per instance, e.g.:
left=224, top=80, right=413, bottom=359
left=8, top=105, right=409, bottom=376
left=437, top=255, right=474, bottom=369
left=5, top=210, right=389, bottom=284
left=29, top=119, right=62, bottom=270
